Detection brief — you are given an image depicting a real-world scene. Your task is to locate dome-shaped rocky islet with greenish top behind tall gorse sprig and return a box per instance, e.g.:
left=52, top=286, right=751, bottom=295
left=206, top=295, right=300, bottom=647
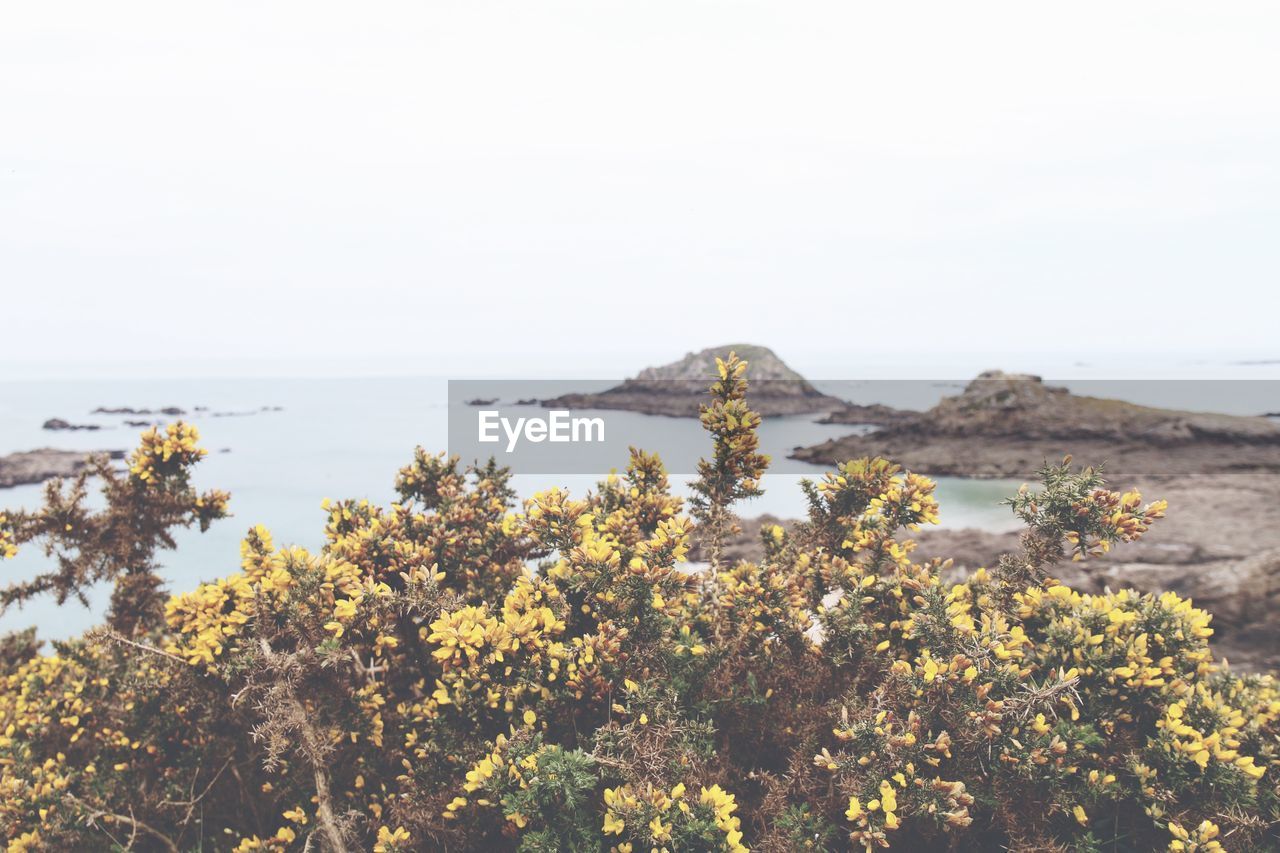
left=541, top=343, right=847, bottom=418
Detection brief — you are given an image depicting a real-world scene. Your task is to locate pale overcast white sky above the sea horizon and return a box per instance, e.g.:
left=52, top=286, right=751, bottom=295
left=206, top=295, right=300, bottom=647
left=0, top=0, right=1280, bottom=378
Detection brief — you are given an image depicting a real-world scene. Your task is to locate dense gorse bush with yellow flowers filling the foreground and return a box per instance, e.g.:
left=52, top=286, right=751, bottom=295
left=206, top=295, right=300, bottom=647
left=0, top=357, right=1280, bottom=853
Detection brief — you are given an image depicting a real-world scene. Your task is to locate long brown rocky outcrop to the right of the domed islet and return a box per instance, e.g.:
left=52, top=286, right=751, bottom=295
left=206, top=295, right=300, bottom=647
left=792, top=370, right=1280, bottom=478
